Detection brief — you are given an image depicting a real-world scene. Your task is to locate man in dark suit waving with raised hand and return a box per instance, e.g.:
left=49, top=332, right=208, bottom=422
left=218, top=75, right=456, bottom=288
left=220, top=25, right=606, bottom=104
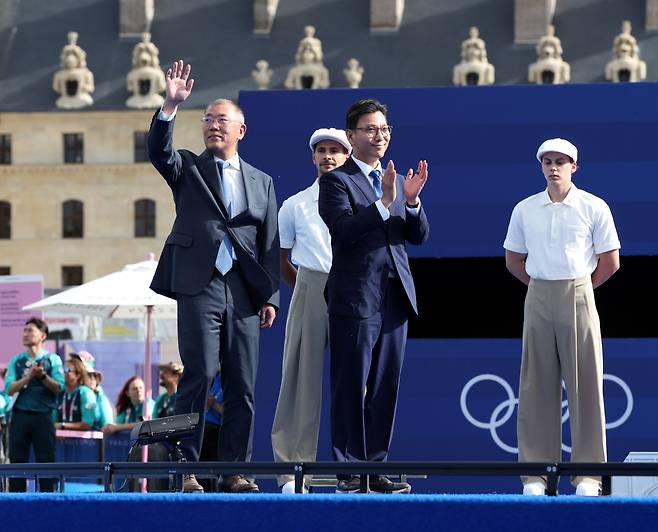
left=148, top=61, right=279, bottom=493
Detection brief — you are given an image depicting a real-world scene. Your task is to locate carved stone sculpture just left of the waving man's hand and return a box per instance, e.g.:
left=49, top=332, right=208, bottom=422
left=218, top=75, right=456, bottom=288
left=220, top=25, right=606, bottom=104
left=126, top=33, right=165, bottom=109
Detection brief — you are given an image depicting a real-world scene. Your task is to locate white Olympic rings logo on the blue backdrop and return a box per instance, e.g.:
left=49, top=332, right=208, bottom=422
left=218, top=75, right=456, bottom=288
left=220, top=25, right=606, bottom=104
left=459, top=373, right=633, bottom=454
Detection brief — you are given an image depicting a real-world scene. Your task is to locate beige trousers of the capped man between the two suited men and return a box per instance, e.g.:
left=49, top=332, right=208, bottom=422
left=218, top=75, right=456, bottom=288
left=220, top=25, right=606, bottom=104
left=272, top=267, right=329, bottom=486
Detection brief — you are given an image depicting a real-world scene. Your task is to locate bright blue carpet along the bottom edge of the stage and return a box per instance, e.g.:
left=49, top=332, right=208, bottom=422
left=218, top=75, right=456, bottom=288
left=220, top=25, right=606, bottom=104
left=0, top=493, right=658, bottom=532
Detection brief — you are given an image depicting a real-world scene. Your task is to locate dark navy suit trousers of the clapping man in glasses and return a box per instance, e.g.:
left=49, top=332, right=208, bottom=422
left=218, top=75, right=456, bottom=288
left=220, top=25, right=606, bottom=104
left=329, top=279, right=409, bottom=462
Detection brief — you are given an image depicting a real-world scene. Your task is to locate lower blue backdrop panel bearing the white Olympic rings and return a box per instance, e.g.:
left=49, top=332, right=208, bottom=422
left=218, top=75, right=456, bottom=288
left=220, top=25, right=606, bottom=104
left=254, top=336, right=658, bottom=493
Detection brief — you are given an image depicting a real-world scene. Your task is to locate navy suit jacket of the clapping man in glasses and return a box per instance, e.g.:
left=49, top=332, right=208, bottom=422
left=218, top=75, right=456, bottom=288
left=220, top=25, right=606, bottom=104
left=319, top=158, right=429, bottom=318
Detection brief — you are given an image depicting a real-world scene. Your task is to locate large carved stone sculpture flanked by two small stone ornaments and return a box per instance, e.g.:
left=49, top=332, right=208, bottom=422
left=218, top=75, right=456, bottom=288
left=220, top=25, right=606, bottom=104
left=284, top=26, right=329, bottom=89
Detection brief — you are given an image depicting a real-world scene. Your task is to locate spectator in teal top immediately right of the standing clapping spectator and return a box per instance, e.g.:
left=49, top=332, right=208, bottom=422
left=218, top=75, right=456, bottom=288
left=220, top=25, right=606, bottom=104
left=55, top=355, right=96, bottom=430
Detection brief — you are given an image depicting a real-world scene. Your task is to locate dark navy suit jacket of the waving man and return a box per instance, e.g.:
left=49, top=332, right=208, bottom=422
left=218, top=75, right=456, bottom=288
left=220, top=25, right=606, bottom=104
left=148, top=113, right=279, bottom=311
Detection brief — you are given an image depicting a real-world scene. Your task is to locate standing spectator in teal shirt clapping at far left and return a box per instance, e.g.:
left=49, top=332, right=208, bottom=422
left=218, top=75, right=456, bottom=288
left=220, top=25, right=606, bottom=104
left=5, top=318, right=64, bottom=492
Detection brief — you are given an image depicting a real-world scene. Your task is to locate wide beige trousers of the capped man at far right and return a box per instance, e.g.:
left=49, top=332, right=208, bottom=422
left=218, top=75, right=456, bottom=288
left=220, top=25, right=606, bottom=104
left=517, top=277, right=607, bottom=484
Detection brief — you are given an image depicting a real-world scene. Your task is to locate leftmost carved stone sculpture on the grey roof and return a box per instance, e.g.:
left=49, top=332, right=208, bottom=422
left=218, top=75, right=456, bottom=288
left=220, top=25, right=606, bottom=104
left=53, top=31, right=94, bottom=109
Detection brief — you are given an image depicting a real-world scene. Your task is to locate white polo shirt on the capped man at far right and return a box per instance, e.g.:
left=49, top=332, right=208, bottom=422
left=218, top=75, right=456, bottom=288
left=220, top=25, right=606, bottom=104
left=503, top=183, right=621, bottom=281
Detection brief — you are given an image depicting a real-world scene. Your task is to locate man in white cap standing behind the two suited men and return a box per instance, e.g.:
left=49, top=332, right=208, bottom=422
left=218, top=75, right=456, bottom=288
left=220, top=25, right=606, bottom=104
left=272, top=128, right=352, bottom=493
